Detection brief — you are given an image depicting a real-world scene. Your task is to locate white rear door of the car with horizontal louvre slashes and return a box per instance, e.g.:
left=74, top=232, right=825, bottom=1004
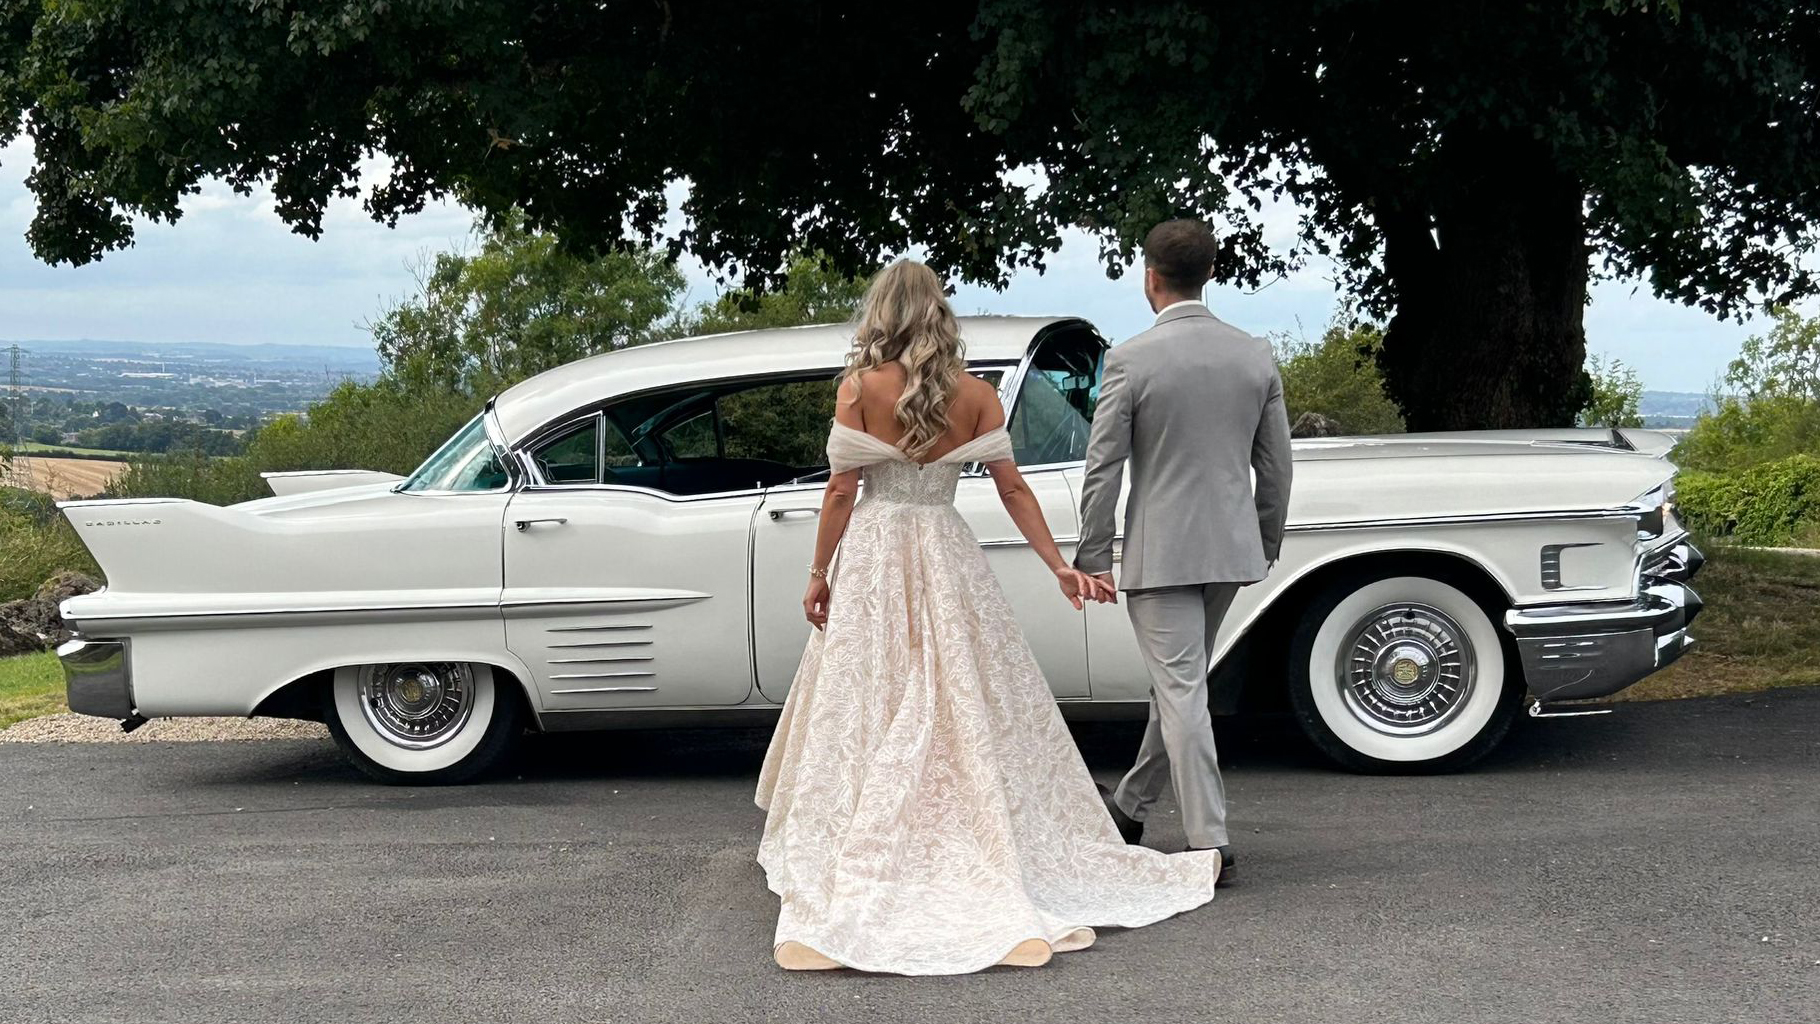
left=501, top=415, right=759, bottom=711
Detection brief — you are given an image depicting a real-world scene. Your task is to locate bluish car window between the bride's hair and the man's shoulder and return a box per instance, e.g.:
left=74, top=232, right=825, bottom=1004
left=1006, top=329, right=1107, bottom=466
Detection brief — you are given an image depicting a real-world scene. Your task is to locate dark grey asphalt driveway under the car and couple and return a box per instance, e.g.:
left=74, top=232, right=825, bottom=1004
left=0, top=689, right=1820, bottom=1024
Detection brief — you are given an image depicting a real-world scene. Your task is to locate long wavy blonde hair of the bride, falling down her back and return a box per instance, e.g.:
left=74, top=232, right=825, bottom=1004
left=841, top=260, right=966, bottom=458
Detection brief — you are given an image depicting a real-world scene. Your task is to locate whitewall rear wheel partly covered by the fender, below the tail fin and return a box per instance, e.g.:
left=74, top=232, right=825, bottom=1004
left=324, top=662, right=521, bottom=786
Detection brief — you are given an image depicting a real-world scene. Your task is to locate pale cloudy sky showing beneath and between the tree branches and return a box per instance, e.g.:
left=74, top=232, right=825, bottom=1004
left=0, top=140, right=1758, bottom=391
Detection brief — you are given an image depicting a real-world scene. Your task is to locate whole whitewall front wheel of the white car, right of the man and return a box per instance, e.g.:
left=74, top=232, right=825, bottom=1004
left=1289, top=577, right=1523, bottom=771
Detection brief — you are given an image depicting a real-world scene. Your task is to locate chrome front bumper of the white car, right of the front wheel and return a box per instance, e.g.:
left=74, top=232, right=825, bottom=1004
left=1503, top=542, right=1705, bottom=702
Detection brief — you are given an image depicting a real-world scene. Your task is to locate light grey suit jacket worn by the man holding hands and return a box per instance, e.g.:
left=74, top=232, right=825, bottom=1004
left=1074, top=304, right=1292, bottom=589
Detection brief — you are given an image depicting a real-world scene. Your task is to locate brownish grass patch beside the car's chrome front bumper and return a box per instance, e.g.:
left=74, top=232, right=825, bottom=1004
left=1618, top=544, right=1820, bottom=700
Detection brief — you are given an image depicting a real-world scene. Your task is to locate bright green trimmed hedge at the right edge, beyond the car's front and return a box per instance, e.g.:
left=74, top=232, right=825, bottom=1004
left=1674, top=455, right=1820, bottom=544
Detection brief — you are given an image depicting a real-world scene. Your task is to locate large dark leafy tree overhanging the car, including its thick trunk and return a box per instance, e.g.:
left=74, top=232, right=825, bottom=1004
left=0, top=0, right=1820, bottom=429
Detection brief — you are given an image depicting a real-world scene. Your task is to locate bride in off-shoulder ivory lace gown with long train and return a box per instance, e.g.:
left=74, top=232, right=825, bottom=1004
left=757, top=260, right=1219, bottom=975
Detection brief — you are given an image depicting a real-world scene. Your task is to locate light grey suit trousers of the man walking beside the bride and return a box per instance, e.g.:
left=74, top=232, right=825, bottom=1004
left=1112, top=584, right=1239, bottom=849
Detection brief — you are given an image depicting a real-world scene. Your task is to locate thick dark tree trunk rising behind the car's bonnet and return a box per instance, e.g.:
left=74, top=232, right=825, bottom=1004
left=1378, top=144, right=1591, bottom=431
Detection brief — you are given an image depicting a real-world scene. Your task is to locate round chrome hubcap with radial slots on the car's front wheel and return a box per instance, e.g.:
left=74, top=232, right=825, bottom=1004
left=1334, top=604, right=1474, bottom=737
